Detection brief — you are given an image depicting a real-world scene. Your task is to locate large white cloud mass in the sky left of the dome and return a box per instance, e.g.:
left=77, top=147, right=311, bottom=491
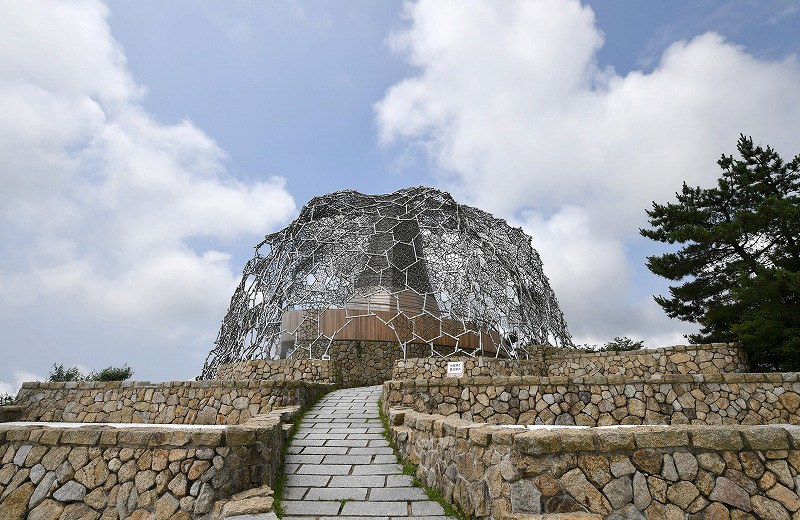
left=0, top=0, right=295, bottom=378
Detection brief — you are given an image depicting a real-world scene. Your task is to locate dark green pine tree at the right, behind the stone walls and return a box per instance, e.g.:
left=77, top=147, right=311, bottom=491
left=640, top=135, right=800, bottom=370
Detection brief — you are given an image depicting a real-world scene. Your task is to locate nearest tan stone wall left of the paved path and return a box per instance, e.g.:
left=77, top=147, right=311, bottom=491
left=0, top=407, right=296, bottom=520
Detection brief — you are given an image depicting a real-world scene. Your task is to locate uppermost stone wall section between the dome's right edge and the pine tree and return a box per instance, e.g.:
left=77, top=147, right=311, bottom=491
left=542, top=343, right=749, bottom=377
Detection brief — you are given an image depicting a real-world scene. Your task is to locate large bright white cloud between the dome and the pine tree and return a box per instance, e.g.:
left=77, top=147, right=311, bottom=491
left=375, top=0, right=800, bottom=341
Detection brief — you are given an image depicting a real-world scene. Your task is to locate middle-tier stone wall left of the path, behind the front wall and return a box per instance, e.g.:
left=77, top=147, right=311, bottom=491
left=16, top=380, right=333, bottom=424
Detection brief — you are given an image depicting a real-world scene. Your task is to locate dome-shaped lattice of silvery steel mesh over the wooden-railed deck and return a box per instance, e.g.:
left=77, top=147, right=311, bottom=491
left=201, top=186, right=572, bottom=378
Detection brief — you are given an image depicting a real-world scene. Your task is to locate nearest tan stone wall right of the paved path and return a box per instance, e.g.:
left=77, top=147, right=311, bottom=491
left=389, top=409, right=800, bottom=520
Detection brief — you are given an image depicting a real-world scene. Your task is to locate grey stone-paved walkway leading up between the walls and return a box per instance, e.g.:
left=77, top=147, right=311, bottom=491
left=283, top=386, right=449, bottom=520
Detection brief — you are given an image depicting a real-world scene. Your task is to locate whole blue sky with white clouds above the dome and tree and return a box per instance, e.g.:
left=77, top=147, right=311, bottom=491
left=0, top=0, right=800, bottom=394
